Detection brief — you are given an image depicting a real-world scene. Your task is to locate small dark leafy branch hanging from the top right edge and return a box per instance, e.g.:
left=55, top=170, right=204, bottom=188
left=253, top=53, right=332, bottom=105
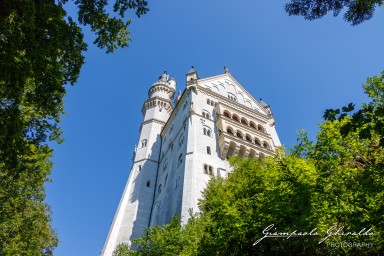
left=285, top=0, right=384, bottom=25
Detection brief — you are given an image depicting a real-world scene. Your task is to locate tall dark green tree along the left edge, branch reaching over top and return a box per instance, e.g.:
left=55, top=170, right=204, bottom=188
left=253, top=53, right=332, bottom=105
left=0, top=0, right=148, bottom=255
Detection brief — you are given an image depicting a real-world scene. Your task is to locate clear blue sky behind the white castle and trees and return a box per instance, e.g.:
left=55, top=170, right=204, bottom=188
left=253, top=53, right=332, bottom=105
left=47, top=0, right=384, bottom=256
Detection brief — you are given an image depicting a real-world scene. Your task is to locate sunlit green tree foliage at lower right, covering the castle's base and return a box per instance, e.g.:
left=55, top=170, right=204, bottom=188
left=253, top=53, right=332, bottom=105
left=117, top=73, right=384, bottom=255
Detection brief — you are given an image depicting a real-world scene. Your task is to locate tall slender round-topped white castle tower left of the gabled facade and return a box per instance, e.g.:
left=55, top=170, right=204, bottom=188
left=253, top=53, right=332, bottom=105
left=101, top=72, right=176, bottom=256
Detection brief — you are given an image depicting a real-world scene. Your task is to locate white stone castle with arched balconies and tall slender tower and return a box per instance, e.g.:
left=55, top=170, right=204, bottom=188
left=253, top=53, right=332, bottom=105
left=101, top=67, right=281, bottom=256
